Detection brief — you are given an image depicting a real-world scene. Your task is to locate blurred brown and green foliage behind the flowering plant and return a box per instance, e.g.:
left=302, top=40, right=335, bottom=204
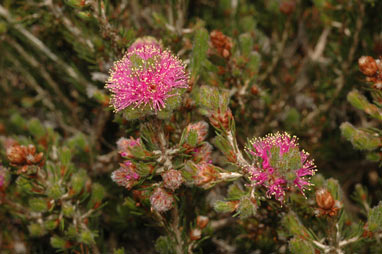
left=0, top=0, right=382, bottom=253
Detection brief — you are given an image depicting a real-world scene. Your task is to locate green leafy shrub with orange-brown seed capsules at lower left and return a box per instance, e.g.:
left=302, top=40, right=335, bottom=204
left=0, top=119, right=106, bottom=252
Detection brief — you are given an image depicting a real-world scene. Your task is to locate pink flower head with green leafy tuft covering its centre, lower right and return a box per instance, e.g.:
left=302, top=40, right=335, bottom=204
left=248, top=133, right=316, bottom=202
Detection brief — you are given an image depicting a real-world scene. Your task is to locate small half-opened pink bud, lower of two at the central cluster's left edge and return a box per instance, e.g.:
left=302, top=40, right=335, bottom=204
left=111, top=161, right=139, bottom=189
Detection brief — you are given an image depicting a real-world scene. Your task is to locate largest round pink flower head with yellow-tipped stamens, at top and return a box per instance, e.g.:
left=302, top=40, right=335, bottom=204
left=106, top=39, right=188, bottom=112
